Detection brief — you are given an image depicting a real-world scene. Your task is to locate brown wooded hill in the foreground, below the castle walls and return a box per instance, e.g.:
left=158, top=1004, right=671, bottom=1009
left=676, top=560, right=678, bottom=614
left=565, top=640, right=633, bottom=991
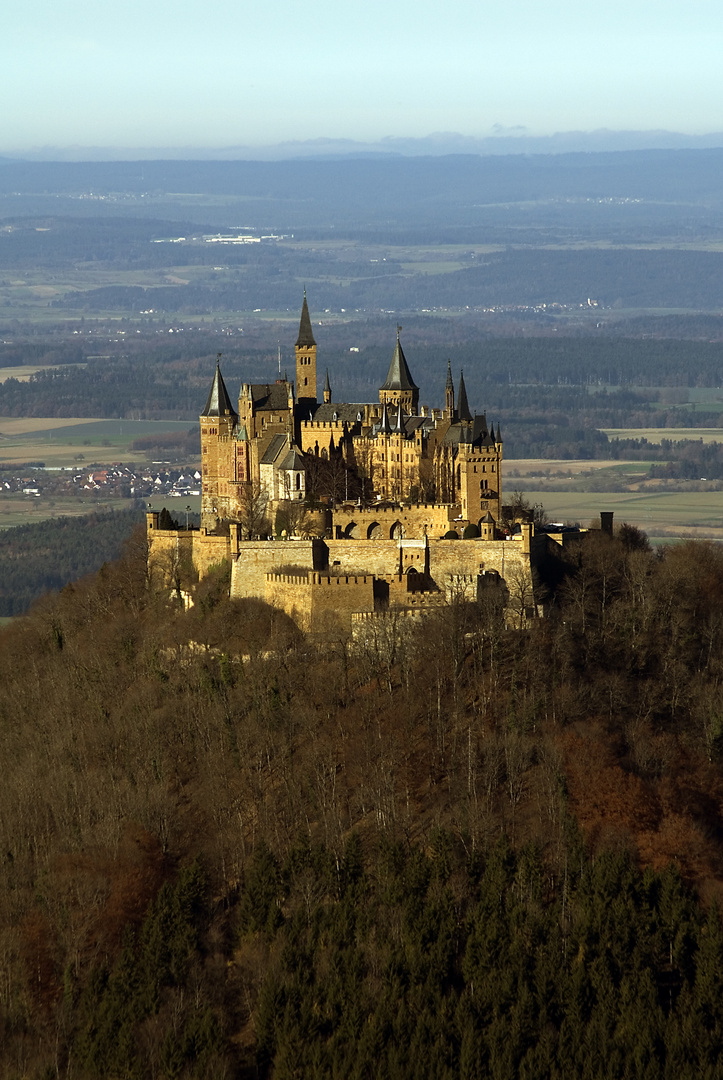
left=0, top=526, right=723, bottom=1080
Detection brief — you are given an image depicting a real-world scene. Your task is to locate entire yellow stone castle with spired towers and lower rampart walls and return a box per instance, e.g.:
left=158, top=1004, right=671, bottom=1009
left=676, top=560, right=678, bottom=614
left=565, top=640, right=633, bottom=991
left=148, top=293, right=536, bottom=637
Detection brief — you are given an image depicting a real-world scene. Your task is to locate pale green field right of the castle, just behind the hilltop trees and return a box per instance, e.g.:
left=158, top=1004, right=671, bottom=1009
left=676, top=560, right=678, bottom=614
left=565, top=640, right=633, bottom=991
left=527, top=491, right=723, bottom=540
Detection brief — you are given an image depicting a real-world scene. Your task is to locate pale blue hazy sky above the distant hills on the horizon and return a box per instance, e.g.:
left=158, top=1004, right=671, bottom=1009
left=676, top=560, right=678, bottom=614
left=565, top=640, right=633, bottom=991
left=0, top=0, right=723, bottom=152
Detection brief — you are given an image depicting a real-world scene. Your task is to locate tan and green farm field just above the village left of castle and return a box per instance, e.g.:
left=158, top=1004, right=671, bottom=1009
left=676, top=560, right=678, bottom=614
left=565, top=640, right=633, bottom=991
left=0, top=417, right=201, bottom=468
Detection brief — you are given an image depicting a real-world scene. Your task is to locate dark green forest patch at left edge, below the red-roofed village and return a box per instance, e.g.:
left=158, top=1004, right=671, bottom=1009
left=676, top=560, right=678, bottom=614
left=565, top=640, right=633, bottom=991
left=0, top=508, right=143, bottom=617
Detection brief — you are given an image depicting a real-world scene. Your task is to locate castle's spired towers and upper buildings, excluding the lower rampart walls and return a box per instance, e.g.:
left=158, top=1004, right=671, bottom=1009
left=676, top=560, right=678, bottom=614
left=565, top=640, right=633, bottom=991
left=201, top=294, right=503, bottom=534
